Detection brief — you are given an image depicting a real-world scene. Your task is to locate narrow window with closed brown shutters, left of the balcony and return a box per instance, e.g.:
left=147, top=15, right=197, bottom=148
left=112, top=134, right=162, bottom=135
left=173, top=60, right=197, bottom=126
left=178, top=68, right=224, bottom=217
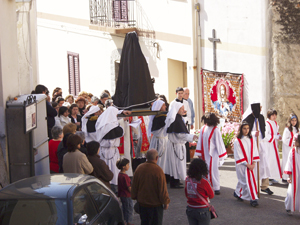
left=68, top=52, right=80, bottom=96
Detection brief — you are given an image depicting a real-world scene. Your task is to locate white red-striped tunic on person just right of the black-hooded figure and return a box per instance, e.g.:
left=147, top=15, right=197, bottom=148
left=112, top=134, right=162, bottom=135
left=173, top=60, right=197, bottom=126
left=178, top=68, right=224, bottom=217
left=265, top=119, right=282, bottom=179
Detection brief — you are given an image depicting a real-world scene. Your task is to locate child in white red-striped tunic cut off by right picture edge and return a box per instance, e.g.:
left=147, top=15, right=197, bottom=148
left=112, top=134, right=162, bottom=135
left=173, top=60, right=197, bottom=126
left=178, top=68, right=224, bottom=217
left=284, top=134, right=300, bottom=215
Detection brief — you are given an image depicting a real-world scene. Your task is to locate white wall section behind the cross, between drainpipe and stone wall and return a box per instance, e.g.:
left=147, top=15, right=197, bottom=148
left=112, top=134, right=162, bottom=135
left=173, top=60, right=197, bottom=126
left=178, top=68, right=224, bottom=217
left=199, top=0, right=267, bottom=112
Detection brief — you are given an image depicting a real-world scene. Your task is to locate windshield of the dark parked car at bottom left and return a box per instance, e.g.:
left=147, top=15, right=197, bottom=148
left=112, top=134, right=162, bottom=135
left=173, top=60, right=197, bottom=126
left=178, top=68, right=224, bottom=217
left=0, top=199, right=68, bottom=225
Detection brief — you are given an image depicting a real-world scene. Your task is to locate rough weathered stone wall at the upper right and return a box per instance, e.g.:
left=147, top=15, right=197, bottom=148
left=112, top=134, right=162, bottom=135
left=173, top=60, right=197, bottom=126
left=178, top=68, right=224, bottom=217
left=269, top=0, right=300, bottom=134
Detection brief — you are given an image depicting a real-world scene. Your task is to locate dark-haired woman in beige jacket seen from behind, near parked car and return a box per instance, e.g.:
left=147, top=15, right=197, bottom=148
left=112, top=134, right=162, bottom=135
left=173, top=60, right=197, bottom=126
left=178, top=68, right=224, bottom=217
left=63, top=134, right=94, bottom=174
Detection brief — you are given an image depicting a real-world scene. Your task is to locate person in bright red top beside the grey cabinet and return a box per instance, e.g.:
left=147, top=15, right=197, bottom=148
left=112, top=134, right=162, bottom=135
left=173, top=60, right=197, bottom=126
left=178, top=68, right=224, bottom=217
left=48, top=126, right=64, bottom=173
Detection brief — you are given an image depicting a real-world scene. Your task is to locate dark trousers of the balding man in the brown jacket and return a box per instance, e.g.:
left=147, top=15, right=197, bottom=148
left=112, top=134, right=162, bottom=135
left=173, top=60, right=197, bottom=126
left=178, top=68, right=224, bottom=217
left=140, top=205, right=164, bottom=225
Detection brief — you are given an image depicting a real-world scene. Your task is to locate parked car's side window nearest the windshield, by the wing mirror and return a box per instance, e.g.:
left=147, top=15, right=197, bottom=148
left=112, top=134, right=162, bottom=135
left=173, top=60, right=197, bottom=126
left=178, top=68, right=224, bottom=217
left=73, top=188, right=97, bottom=224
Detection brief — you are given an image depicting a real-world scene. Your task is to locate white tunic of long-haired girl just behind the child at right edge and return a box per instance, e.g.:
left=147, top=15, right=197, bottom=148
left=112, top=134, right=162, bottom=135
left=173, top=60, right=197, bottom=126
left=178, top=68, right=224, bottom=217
left=281, top=127, right=297, bottom=180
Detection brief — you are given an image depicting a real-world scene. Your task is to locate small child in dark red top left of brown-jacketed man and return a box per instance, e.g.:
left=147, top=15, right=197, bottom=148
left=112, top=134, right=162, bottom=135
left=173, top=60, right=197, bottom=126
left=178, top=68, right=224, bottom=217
left=116, top=158, right=133, bottom=225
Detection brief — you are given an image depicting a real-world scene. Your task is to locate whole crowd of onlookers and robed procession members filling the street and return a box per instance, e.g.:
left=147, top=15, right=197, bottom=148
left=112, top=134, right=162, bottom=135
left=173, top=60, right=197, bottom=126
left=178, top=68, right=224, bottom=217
left=34, top=85, right=300, bottom=224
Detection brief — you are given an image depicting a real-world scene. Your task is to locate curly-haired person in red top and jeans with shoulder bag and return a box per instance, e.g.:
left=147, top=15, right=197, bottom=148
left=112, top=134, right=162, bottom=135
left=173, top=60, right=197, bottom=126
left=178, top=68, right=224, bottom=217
left=185, top=158, right=214, bottom=225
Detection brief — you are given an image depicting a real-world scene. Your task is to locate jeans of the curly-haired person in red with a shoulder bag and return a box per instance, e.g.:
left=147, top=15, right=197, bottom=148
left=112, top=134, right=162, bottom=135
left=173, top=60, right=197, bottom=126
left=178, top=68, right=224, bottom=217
left=186, top=206, right=211, bottom=225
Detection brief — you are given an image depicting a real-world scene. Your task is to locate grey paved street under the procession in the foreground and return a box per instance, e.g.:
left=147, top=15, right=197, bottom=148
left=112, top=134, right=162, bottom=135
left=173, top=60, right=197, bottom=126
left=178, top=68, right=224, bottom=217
left=133, top=158, right=300, bottom=225
